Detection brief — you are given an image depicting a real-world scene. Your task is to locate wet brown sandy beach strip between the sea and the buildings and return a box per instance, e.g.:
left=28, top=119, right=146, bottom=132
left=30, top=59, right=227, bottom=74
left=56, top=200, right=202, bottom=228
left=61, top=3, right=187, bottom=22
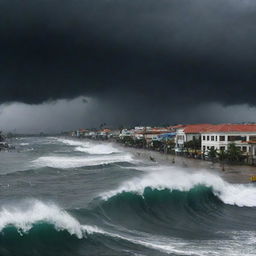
left=113, top=141, right=256, bottom=184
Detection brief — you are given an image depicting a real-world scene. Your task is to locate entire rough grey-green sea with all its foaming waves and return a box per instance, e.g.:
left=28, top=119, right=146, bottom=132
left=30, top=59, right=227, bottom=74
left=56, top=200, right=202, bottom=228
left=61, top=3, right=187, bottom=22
left=0, top=137, right=256, bottom=256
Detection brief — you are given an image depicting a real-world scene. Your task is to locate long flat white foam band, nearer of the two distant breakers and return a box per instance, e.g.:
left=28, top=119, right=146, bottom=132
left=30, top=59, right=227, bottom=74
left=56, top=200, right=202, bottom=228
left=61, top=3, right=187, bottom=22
left=32, top=154, right=133, bottom=169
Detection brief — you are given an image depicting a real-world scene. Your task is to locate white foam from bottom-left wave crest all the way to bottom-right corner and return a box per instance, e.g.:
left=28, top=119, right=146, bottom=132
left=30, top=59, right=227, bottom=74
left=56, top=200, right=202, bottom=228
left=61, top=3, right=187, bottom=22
left=0, top=200, right=255, bottom=256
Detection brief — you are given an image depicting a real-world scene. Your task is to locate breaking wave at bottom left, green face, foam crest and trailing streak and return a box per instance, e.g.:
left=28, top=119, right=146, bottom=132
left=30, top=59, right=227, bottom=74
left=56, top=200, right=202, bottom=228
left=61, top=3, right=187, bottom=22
left=0, top=200, right=197, bottom=255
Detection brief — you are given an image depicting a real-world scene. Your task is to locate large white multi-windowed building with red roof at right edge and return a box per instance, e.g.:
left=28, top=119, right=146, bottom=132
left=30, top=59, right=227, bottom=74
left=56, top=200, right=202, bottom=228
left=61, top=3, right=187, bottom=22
left=201, top=124, right=256, bottom=158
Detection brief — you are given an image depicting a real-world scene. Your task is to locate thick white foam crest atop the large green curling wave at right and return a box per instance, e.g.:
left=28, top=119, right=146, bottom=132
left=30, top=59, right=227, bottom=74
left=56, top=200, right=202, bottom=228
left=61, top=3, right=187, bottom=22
left=101, top=166, right=256, bottom=207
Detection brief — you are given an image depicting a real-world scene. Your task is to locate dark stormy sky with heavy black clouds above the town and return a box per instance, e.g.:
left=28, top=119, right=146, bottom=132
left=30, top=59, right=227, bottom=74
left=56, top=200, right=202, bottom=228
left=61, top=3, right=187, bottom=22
left=0, top=0, right=256, bottom=132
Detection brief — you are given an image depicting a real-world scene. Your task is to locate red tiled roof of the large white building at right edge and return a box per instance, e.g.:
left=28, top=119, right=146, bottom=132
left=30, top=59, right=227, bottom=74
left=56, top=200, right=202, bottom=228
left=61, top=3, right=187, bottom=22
left=205, top=124, right=256, bottom=132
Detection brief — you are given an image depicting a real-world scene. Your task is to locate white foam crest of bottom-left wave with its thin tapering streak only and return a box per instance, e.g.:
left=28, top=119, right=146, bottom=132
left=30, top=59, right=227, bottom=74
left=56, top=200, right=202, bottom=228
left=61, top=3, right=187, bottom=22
left=0, top=200, right=190, bottom=254
